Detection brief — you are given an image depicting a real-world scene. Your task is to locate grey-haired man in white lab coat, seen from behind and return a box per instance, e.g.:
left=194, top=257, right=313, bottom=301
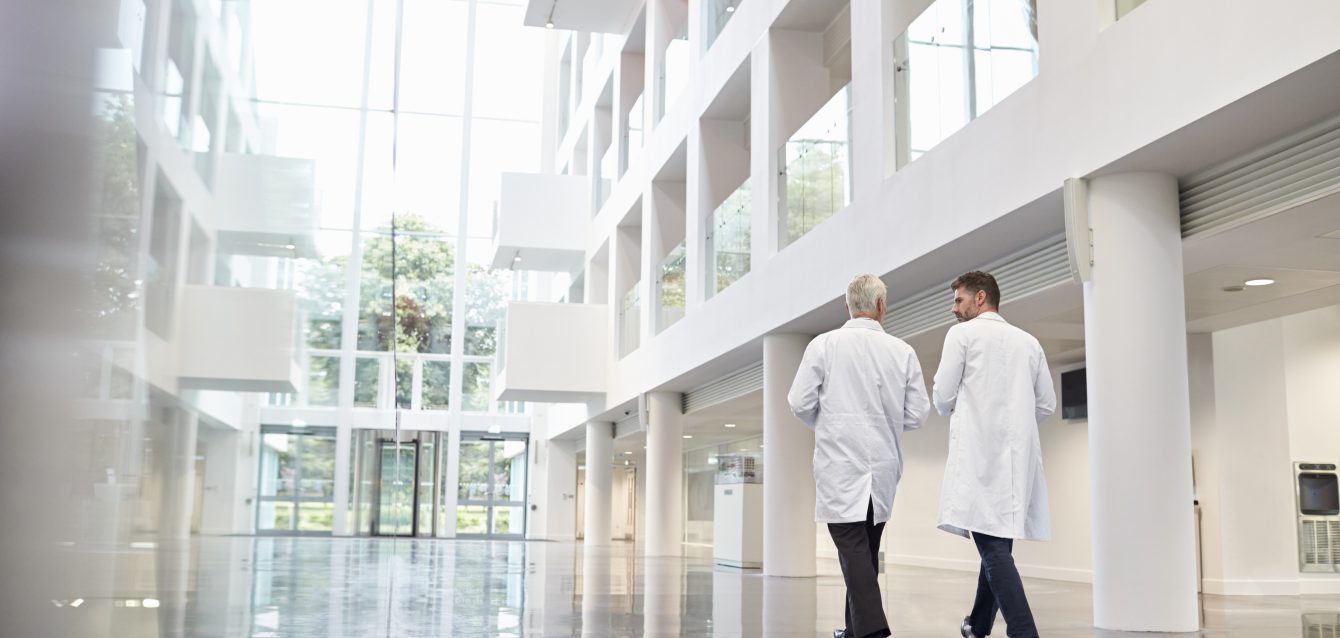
left=787, top=275, right=930, bottom=638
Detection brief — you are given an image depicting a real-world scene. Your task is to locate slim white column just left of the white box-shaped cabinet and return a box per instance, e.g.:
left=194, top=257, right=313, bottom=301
left=645, top=393, right=683, bottom=556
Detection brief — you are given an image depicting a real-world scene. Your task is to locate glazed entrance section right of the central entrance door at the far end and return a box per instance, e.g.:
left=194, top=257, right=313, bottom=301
left=456, top=433, right=527, bottom=539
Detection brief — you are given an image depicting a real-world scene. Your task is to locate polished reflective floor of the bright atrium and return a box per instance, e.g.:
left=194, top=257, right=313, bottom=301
left=79, top=537, right=1340, bottom=638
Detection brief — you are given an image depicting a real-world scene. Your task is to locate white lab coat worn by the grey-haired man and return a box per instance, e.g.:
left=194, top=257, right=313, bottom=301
left=787, top=319, right=930, bottom=524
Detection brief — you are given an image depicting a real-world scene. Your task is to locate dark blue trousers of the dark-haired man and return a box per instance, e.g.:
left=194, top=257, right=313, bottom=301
left=967, top=532, right=1037, bottom=638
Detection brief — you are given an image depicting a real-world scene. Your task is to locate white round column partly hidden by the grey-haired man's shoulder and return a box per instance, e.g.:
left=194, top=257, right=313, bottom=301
left=762, top=335, right=815, bottom=578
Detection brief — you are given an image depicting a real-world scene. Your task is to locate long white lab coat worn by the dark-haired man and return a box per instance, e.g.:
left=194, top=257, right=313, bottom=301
left=934, top=312, right=1056, bottom=540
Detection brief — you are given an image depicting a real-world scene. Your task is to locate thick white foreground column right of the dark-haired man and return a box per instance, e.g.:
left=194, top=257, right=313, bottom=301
left=1084, top=173, right=1199, bottom=631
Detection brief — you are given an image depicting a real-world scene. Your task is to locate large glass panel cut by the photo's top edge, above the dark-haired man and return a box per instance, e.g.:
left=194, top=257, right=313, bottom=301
left=894, top=0, right=1037, bottom=168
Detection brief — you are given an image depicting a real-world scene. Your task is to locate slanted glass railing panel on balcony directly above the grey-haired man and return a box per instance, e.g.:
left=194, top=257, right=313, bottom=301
left=779, top=86, right=851, bottom=248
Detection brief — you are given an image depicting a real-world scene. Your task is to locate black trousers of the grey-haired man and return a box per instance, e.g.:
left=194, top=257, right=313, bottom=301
left=828, top=501, right=890, bottom=638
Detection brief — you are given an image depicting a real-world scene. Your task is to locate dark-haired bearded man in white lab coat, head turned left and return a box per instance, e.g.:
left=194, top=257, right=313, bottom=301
left=934, top=271, right=1056, bottom=638
